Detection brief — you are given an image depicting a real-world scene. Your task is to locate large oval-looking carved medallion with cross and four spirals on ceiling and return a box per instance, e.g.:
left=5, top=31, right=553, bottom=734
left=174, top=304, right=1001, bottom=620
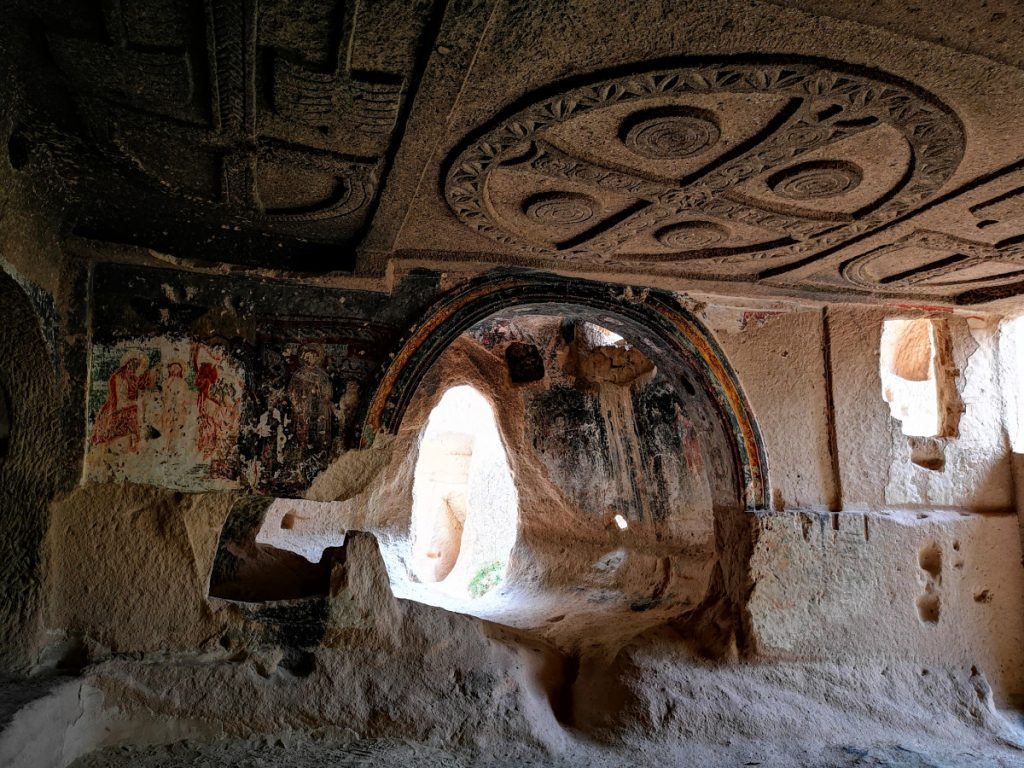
left=444, top=59, right=965, bottom=274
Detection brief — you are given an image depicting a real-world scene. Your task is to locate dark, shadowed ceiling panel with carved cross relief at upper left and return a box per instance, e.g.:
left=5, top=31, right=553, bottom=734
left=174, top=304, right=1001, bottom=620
left=12, top=0, right=431, bottom=270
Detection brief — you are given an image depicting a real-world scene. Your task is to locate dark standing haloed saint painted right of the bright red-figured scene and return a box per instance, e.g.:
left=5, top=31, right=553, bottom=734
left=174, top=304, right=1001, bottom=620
left=288, top=344, right=334, bottom=463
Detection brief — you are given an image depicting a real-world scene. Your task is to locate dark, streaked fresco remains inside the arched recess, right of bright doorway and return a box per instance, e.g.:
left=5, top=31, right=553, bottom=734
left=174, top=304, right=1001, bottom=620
left=469, top=315, right=737, bottom=541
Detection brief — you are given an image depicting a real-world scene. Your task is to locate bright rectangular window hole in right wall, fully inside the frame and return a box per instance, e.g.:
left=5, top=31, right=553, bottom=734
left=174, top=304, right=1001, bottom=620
left=880, top=318, right=941, bottom=437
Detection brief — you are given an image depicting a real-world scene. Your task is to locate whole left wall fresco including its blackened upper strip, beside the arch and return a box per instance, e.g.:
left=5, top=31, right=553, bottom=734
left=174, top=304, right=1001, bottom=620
left=85, top=266, right=436, bottom=496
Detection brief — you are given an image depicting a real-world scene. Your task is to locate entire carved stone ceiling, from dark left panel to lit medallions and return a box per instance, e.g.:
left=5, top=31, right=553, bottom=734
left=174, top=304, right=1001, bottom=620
left=5, top=0, right=1024, bottom=304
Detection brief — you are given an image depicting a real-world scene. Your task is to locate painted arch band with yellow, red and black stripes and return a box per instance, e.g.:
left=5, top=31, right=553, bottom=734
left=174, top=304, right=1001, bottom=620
left=360, top=274, right=770, bottom=510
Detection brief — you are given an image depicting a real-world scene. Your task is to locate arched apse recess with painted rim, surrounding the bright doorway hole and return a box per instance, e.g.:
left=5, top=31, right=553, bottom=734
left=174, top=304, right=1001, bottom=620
left=362, top=275, right=767, bottom=645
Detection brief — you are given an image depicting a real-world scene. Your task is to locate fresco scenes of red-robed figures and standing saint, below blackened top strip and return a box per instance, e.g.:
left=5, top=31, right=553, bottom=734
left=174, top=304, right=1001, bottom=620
left=86, top=319, right=372, bottom=495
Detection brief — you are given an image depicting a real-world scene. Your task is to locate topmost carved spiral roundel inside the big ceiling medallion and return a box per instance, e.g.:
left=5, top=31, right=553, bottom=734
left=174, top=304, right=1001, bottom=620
left=621, top=106, right=721, bottom=160
